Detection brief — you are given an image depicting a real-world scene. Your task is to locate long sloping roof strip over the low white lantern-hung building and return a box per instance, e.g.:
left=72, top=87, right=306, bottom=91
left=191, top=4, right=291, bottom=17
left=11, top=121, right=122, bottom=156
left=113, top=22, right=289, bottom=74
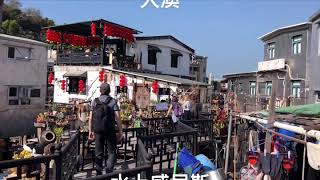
left=105, top=68, right=209, bottom=86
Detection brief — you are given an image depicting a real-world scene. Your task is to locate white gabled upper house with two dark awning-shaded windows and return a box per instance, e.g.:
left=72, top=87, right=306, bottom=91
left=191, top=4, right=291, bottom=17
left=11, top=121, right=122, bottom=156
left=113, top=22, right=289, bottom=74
left=136, top=36, right=194, bottom=78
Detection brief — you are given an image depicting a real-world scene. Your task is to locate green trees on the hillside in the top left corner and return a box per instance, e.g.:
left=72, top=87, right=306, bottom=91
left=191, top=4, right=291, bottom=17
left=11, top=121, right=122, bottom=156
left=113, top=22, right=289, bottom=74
left=1, top=0, right=54, bottom=40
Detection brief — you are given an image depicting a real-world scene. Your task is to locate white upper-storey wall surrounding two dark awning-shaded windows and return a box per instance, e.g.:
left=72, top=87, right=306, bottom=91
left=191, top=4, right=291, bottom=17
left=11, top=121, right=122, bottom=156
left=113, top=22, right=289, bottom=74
left=136, top=39, right=193, bottom=76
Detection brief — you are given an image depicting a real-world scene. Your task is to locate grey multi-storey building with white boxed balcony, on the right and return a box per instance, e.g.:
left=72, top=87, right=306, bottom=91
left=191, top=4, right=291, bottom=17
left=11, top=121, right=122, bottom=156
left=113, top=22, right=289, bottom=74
left=257, top=22, right=311, bottom=105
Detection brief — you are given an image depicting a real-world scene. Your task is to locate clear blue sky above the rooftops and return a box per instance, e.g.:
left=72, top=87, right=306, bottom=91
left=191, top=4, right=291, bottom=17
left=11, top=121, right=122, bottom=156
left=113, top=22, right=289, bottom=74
left=21, top=0, right=320, bottom=78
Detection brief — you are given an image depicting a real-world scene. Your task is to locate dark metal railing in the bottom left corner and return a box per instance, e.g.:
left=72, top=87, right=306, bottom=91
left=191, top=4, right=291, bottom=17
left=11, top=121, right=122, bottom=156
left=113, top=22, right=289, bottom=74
left=0, top=133, right=79, bottom=180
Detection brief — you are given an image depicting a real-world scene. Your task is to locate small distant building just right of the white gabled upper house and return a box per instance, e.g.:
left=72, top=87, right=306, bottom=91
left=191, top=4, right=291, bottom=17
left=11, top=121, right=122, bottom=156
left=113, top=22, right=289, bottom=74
left=190, top=56, right=208, bottom=83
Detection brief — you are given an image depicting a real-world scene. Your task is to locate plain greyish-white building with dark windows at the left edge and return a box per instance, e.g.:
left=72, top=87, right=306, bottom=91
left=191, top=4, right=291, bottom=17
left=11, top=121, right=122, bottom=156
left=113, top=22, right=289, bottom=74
left=0, top=34, right=47, bottom=137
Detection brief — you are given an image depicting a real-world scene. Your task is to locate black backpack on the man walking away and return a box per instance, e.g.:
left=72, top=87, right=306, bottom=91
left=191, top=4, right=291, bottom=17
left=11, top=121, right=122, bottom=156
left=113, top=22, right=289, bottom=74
left=92, top=97, right=115, bottom=133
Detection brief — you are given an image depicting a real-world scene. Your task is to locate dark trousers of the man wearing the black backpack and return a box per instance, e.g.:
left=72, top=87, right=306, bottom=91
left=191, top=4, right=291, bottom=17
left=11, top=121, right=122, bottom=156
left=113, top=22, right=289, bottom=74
left=95, top=132, right=117, bottom=175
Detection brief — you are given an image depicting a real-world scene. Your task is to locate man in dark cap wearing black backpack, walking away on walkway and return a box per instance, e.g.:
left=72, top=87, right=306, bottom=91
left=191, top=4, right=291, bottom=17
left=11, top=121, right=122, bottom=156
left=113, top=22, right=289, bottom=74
left=89, top=83, right=123, bottom=175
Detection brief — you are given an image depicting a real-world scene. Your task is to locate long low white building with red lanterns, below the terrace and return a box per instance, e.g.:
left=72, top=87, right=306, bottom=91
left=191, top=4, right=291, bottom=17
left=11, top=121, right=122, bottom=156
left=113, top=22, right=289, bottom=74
left=54, top=66, right=207, bottom=108
